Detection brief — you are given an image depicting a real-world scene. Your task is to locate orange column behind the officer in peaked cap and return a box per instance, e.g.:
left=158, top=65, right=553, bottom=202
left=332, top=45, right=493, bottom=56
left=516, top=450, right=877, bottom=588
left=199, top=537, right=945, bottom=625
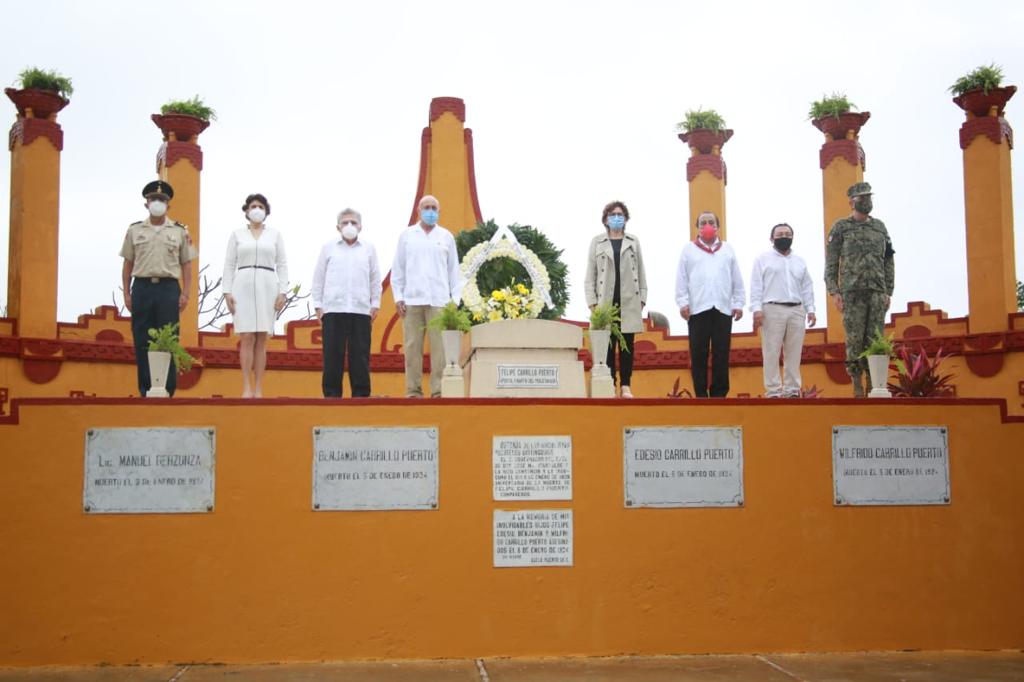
left=152, top=114, right=210, bottom=346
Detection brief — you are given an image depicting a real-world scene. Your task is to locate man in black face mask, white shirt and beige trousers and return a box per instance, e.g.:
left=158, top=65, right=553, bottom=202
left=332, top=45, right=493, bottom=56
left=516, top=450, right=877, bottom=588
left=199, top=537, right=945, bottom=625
left=751, top=222, right=817, bottom=397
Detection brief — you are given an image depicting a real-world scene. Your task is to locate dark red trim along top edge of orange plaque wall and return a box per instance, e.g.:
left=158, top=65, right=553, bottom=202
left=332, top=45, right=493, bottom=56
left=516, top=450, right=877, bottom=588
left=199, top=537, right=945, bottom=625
left=0, top=397, right=1024, bottom=424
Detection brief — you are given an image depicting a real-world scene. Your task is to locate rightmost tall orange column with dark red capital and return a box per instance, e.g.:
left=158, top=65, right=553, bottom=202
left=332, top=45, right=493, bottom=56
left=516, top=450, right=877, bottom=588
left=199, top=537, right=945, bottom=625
left=953, top=86, right=1017, bottom=332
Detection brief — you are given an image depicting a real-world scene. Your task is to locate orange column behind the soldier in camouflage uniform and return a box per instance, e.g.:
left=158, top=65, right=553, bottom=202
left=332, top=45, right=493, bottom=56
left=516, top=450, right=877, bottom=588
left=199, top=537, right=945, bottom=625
left=813, top=112, right=871, bottom=343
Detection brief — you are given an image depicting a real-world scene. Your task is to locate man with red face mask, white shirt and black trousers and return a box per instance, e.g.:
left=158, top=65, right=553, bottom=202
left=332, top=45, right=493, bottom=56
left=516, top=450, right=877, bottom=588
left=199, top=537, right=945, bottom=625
left=676, top=211, right=746, bottom=397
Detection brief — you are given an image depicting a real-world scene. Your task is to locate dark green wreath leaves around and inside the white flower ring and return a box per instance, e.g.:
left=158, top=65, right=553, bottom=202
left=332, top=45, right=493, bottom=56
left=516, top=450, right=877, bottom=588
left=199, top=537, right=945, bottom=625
left=455, top=220, right=569, bottom=319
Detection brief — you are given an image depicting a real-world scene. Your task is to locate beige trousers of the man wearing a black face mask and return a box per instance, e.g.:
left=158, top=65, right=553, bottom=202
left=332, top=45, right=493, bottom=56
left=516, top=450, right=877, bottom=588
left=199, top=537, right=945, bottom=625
left=761, top=303, right=807, bottom=397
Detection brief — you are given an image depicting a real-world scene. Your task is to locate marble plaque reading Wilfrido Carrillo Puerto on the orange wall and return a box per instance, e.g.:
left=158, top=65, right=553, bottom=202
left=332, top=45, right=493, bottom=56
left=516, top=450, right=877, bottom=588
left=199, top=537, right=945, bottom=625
left=833, top=426, right=949, bottom=505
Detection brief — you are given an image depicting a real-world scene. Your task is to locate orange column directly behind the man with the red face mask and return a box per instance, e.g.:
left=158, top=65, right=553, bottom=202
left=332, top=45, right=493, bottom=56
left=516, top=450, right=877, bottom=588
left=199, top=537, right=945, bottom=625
left=679, top=128, right=732, bottom=240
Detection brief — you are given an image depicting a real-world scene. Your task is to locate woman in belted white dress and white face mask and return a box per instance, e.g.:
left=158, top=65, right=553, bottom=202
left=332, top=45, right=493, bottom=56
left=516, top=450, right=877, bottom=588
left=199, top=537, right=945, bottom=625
left=221, top=195, right=288, bottom=397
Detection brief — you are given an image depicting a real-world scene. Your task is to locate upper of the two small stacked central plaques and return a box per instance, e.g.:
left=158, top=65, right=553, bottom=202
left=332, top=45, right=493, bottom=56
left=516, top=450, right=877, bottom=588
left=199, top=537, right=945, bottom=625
left=490, top=436, right=572, bottom=500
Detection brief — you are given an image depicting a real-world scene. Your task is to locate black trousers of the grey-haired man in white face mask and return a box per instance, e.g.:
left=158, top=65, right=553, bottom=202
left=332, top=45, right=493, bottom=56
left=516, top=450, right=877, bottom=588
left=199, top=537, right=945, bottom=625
left=321, top=312, right=370, bottom=397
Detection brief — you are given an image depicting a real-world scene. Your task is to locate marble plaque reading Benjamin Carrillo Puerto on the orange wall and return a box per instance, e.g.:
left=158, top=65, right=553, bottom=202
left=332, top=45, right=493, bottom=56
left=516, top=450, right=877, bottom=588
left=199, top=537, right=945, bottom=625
left=313, top=426, right=438, bottom=511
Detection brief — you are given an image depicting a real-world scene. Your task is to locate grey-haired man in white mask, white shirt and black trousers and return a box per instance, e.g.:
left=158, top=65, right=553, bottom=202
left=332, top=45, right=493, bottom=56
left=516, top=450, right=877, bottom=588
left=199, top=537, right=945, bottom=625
left=310, top=209, right=381, bottom=397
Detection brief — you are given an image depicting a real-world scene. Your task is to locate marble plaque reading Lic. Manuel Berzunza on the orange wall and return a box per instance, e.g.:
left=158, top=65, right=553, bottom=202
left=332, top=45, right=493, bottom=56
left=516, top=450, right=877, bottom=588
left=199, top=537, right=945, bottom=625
left=82, top=426, right=216, bottom=514
